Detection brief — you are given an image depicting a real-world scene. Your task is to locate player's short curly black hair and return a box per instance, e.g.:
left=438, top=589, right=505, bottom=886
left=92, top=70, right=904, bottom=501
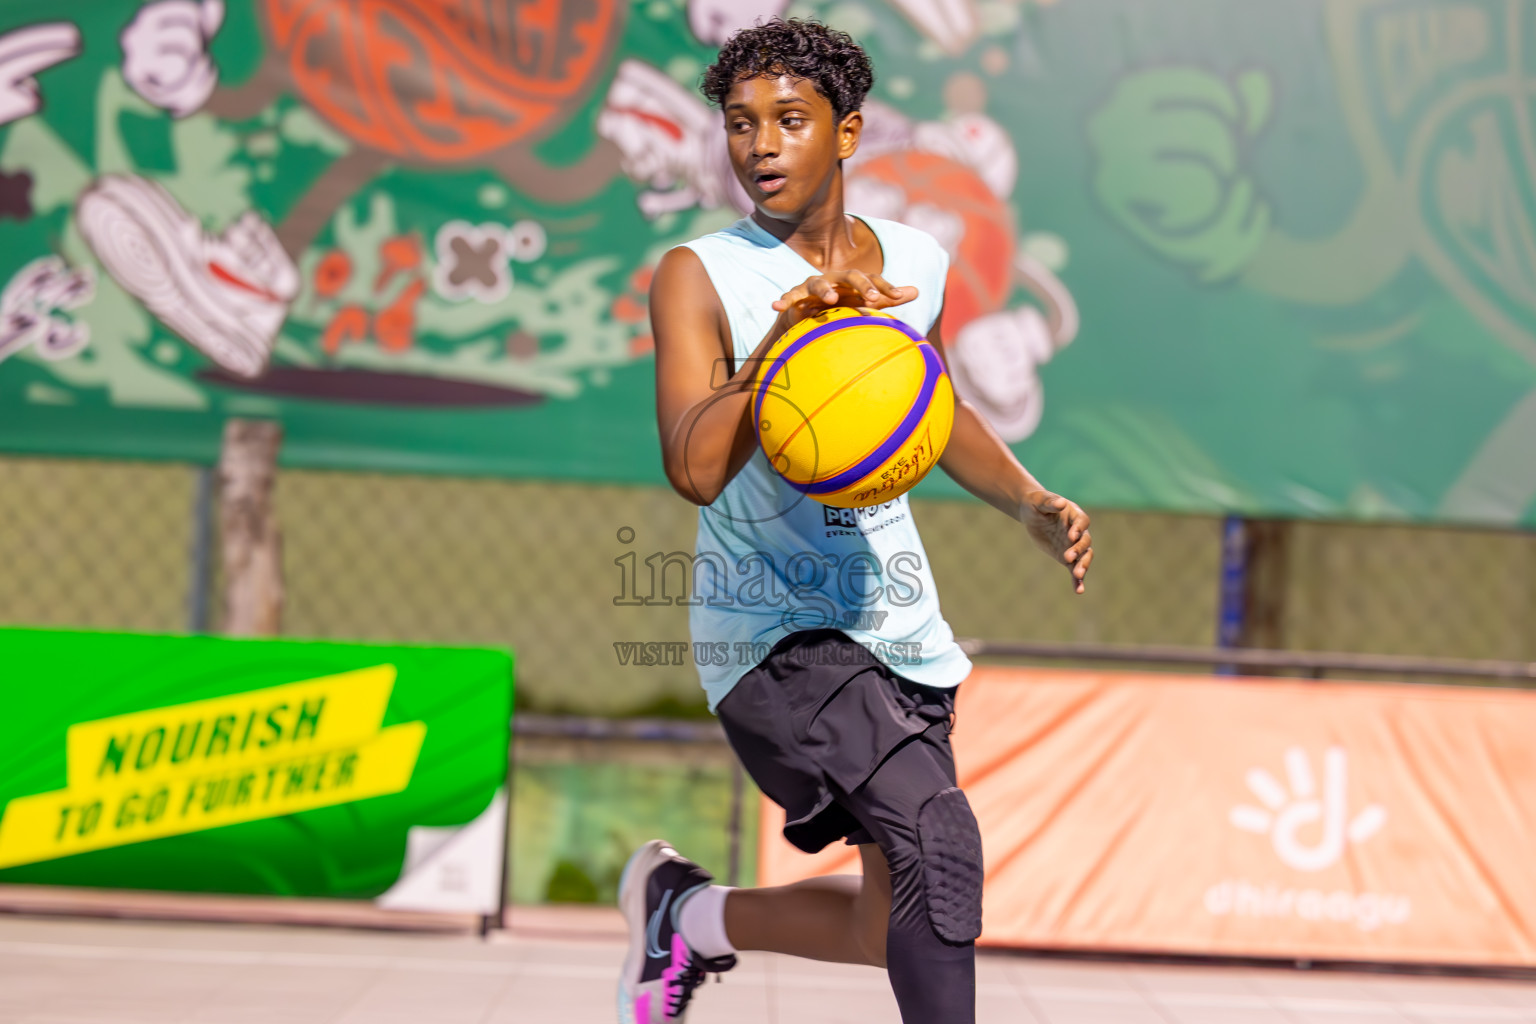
left=699, top=18, right=874, bottom=120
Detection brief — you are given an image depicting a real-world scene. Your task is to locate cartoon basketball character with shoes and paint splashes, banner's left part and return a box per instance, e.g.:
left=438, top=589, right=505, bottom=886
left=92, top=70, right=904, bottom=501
left=10, top=0, right=633, bottom=407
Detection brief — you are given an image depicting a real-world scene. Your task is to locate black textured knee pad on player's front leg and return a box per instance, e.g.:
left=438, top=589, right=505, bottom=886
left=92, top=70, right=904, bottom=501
left=917, top=786, right=982, bottom=943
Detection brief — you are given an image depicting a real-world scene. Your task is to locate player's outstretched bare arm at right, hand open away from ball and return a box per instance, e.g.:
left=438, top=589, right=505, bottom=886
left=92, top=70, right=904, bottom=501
left=928, top=313, right=1094, bottom=594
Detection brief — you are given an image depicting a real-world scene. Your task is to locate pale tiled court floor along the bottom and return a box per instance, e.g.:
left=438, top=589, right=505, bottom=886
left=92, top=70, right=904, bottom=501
left=0, top=917, right=1536, bottom=1024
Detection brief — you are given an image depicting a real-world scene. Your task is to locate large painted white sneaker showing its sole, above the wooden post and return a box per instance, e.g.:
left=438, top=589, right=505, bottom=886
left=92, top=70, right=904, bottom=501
left=75, top=175, right=298, bottom=378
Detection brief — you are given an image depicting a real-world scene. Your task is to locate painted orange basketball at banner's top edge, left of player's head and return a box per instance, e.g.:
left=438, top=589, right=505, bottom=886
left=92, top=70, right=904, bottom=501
left=266, top=0, right=622, bottom=163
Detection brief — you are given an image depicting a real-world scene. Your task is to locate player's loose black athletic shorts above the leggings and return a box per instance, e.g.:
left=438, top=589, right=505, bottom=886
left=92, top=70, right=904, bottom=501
left=716, top=629, right=955, bottom=854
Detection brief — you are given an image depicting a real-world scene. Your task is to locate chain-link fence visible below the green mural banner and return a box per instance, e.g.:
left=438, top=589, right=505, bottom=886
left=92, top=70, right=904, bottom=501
left=0, top=457, right=1536, bottom=901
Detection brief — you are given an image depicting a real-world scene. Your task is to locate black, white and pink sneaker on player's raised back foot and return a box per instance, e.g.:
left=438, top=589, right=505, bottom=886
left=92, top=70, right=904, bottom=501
left=619, top=840, right=736, bottom=1024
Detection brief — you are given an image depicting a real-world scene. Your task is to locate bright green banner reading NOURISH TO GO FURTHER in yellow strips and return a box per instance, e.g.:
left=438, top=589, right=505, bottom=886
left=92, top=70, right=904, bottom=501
left=0, top=629, right=511, bottom=913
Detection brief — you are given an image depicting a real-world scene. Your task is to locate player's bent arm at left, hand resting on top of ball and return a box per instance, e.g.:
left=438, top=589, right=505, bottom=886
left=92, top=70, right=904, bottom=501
left=650, top=247, right=917, bottom=505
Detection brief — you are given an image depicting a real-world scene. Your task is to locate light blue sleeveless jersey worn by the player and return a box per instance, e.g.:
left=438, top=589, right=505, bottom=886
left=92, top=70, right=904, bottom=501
left=687, top=216, right=971, bottom=711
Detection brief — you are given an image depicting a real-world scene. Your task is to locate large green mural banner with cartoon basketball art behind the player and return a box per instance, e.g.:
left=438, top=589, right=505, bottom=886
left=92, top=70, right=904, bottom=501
left=0, top=0, right=1536, bottom=525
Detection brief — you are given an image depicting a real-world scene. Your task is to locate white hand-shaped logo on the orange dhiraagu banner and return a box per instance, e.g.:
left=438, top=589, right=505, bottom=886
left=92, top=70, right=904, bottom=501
left=1227, top=746, right=1387, bottom=870
